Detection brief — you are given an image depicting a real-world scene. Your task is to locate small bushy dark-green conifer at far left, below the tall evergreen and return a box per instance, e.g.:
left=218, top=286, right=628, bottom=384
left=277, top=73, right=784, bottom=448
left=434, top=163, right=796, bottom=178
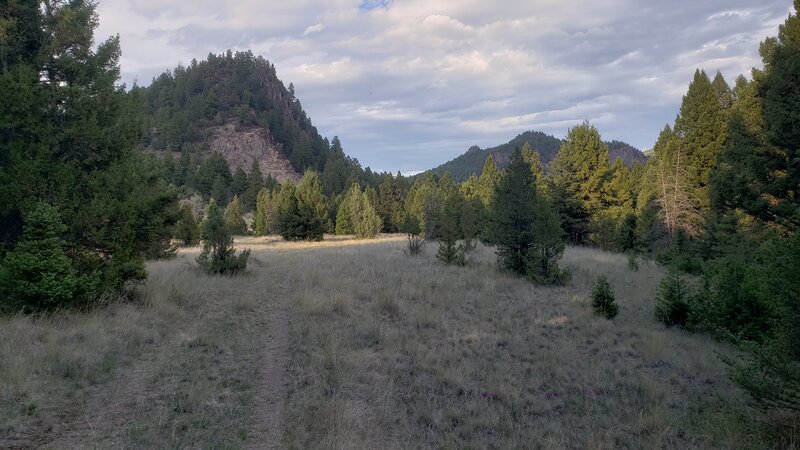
left=0, top=203, right=79, bottom=312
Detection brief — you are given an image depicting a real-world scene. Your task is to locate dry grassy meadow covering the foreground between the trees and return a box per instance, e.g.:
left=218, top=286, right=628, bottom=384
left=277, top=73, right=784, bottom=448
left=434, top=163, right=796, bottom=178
left=0, top=235, right=800, bottom=449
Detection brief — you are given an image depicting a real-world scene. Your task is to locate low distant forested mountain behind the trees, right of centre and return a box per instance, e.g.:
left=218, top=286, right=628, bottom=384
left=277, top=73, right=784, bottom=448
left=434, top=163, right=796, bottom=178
left=429, top=131, right=647, bottom=181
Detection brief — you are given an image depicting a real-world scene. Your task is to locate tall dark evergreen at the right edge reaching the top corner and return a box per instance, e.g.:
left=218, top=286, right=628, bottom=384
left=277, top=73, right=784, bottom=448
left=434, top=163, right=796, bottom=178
left=711, top=3, right=800, bottom=234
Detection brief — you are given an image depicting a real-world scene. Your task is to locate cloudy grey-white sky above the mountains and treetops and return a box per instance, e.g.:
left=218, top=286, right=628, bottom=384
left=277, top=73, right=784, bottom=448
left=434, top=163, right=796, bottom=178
left=95, top=0, right=792, bottom=173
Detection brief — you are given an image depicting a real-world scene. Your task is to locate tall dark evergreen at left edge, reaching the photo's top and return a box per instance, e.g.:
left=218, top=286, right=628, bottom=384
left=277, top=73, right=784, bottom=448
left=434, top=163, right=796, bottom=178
left=0, top=1, right=176, bottom=300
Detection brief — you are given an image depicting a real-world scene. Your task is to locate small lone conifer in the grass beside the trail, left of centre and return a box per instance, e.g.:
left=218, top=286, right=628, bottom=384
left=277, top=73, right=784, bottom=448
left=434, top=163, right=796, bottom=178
left=197, top=198, right=250, bottom=275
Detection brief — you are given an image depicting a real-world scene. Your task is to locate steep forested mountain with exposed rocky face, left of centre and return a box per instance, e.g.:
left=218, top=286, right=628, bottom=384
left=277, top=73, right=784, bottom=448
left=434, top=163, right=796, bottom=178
left=136, top=51, right=331, bottom=180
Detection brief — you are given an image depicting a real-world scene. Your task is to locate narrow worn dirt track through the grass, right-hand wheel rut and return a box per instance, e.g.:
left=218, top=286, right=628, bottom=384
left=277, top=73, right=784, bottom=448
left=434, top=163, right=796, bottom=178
left=246, top=295, right=289, bottom=449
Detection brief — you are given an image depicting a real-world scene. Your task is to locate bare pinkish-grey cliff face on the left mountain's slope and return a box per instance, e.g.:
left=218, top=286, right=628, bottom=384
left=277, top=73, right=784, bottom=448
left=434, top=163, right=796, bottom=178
left=206, top=123, right=301, bottom=183
